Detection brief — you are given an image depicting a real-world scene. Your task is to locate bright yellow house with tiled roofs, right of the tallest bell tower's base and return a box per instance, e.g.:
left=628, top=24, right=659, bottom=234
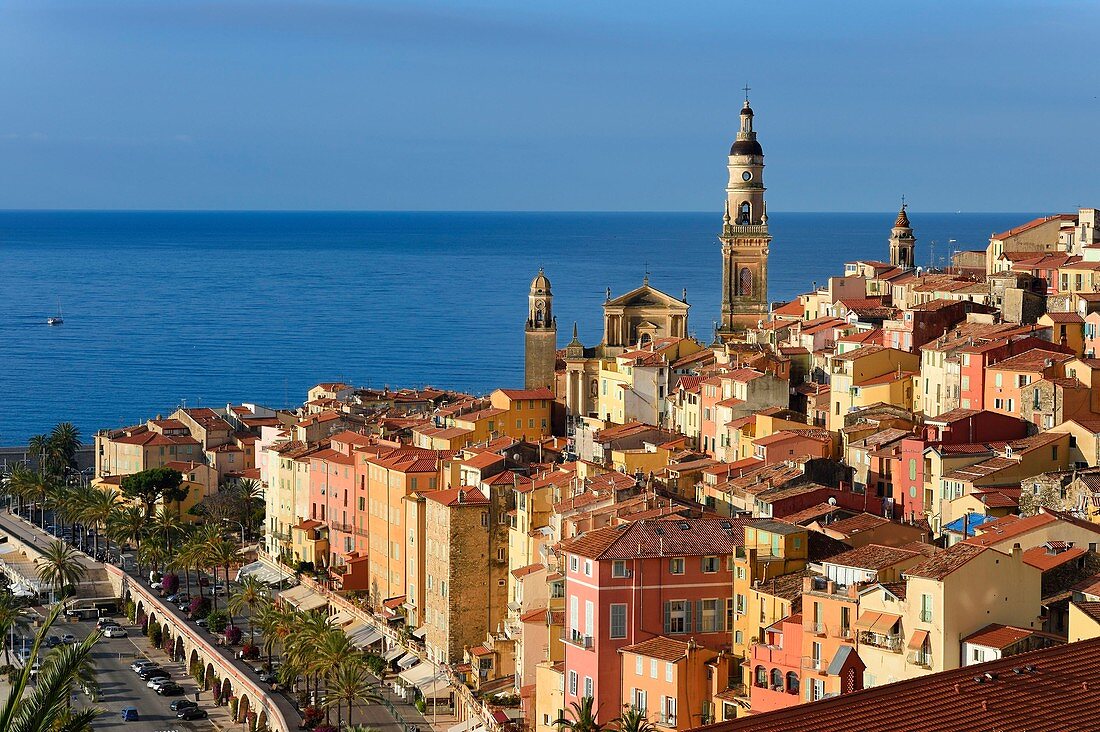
left=827, top=345, right=920, bottom=431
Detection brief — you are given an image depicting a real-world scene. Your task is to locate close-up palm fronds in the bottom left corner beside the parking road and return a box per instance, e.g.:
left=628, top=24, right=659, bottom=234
left=0, top=603, right=100, bottom=732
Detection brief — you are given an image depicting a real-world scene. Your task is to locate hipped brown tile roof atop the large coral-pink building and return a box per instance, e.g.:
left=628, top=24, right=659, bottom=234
left=561, top=518, right=747, bottom=559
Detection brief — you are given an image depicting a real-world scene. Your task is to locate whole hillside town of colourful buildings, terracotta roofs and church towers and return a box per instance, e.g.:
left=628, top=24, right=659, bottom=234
left=60, top=100, right=1100, bottom=732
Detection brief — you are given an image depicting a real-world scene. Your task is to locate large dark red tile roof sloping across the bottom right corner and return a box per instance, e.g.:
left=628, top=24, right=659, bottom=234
left=696, top=638, right=1100, bottom=732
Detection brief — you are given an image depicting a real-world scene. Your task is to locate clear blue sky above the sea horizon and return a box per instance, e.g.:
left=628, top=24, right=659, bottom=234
left=0, top=0, right=1100, bottom=211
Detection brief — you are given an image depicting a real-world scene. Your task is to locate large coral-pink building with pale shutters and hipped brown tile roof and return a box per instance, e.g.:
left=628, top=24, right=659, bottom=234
left=562, top=518, right=744, bottom=722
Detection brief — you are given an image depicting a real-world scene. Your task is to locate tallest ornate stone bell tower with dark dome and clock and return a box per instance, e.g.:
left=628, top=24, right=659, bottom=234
left=718, top=96, right=771, bottom=339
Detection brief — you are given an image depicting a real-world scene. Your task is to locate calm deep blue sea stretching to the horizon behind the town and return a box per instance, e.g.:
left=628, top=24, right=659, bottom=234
left=0, top=211, right=1031, bottom=445
